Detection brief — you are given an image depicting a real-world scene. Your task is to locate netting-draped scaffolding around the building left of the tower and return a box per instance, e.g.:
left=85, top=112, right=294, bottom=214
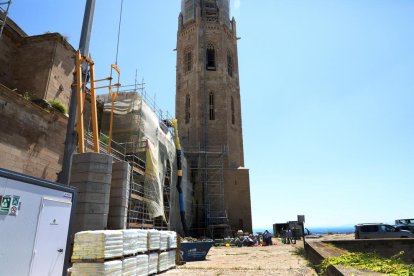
left=85, top=83, right=192, bottom=232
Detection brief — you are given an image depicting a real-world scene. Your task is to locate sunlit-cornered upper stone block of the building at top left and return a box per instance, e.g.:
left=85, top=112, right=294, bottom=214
left=0, top=16, right=75, bottom=108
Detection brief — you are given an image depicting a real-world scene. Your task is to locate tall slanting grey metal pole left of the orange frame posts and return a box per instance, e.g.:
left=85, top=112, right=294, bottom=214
left=58, top=0, right=96, bottom=185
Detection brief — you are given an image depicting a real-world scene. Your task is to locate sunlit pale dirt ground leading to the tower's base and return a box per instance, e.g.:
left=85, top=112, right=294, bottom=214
left=164, top=239, right=317, bottom=276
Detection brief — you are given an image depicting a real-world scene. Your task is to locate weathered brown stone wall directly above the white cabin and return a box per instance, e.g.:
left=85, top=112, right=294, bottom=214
left=0, top=85, right=67, bottom=181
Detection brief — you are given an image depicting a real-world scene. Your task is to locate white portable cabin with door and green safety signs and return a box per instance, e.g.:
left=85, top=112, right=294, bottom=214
left=0, top=168, right=76, bottom=276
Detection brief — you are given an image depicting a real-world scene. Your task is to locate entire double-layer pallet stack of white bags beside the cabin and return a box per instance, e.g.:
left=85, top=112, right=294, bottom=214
left=70, top=229, right=177, bottom=276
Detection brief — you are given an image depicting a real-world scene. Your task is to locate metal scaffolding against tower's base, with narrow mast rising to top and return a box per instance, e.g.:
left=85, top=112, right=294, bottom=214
left=187, top=0, right=231, bottom=238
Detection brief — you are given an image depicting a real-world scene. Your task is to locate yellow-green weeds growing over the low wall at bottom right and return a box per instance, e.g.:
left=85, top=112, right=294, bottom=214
left=320, top=251, right=414, bottom=275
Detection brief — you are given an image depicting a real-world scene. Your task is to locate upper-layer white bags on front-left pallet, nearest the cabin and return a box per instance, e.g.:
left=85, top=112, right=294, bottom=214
left=72, top=230, right=124, bottom=260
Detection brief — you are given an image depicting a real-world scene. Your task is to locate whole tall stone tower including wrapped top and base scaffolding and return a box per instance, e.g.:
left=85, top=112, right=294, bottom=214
left=176, top=0, right=252, bottom=232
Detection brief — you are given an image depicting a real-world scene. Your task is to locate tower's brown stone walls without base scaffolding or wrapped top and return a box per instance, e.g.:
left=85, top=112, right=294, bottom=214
left=176, top=2, right=252, bottom=235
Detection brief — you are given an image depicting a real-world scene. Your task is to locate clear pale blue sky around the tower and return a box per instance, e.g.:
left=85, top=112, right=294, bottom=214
left=10, top=0, right=414, bottom=228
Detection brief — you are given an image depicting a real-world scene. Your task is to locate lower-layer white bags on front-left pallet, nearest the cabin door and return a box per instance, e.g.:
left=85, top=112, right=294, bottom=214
left=72, top=261, right=122, bottom=276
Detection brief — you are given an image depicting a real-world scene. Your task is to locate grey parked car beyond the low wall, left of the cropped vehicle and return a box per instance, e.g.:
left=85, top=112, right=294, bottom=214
left=355, top=223, right=414, bottom=239
